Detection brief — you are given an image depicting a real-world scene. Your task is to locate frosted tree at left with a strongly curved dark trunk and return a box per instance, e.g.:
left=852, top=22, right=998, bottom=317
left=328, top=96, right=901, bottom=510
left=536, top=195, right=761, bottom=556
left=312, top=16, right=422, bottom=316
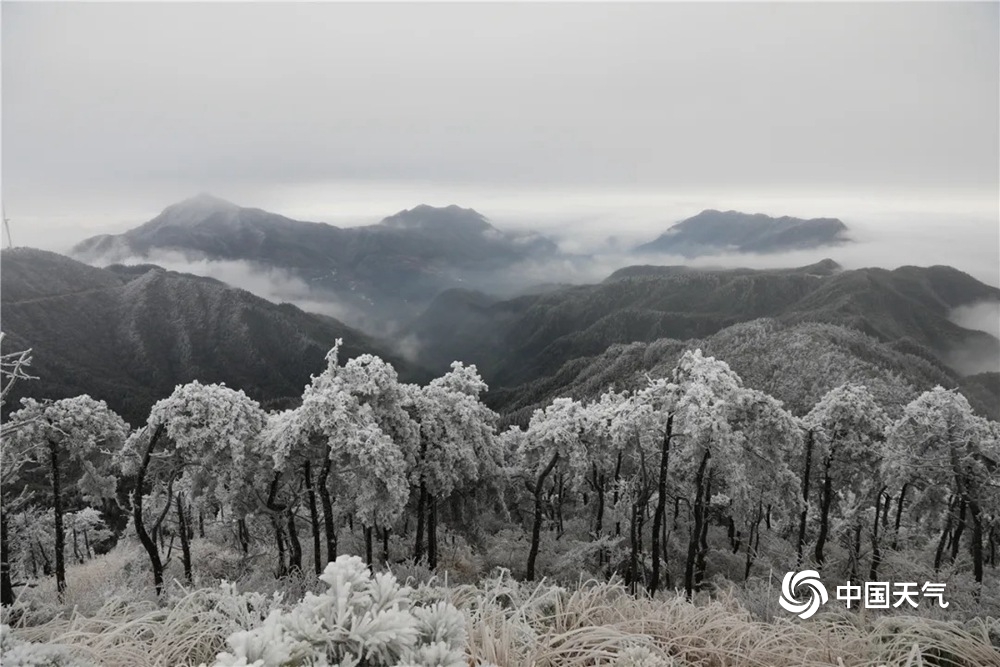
left=119, top=381, right=266, bottom=594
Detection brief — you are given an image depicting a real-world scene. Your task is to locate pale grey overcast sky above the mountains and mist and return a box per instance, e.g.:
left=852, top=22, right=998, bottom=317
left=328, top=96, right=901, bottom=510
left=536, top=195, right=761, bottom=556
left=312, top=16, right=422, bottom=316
left=0, top=1, right=1000, bottom=254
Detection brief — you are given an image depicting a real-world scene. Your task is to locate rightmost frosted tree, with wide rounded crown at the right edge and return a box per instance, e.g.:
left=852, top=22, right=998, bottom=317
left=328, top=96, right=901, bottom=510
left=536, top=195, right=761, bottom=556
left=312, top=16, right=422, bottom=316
left=882, top=387, right=1000, bottom=584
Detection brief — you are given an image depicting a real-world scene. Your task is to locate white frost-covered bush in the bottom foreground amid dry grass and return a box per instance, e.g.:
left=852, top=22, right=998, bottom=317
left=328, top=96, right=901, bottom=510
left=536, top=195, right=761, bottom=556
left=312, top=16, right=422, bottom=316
left=206, top=556, right=466, bottom=667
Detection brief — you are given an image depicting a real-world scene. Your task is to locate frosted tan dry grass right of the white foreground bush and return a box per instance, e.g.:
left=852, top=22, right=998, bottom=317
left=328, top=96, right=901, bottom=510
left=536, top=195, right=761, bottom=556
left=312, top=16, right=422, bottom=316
left=450, top=579, right=1000, bottom=667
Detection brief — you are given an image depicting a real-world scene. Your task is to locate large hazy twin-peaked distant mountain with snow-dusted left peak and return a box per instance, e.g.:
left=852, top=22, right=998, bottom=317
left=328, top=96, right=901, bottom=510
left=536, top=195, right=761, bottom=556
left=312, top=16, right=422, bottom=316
left=71, top=194, right=558, bottom=330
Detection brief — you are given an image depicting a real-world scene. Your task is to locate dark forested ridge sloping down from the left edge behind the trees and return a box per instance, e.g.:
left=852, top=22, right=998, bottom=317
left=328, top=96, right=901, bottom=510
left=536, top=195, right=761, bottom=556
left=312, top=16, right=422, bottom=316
left=0, top=248, right=426, bottom=423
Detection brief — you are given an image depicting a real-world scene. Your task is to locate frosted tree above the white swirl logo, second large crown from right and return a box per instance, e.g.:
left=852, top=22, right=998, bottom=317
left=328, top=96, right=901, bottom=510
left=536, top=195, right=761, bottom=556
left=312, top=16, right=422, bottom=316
left=804, top=384, right=890, bottom=565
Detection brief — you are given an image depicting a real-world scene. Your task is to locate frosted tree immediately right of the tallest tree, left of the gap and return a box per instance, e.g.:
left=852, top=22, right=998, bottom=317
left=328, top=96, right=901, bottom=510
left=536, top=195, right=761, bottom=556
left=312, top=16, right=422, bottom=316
left=409, top=361, right=500, bottom=569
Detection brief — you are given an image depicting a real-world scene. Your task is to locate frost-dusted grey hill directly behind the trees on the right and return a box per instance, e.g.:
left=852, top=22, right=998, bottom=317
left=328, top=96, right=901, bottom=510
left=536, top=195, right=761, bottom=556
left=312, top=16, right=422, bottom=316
left=488, top=318, right=1000, bottom=424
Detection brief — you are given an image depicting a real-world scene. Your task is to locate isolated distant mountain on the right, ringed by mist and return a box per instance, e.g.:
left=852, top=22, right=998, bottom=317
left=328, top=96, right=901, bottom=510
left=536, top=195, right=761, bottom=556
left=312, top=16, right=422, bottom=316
left=636, top=209, right=848, bottom=257
